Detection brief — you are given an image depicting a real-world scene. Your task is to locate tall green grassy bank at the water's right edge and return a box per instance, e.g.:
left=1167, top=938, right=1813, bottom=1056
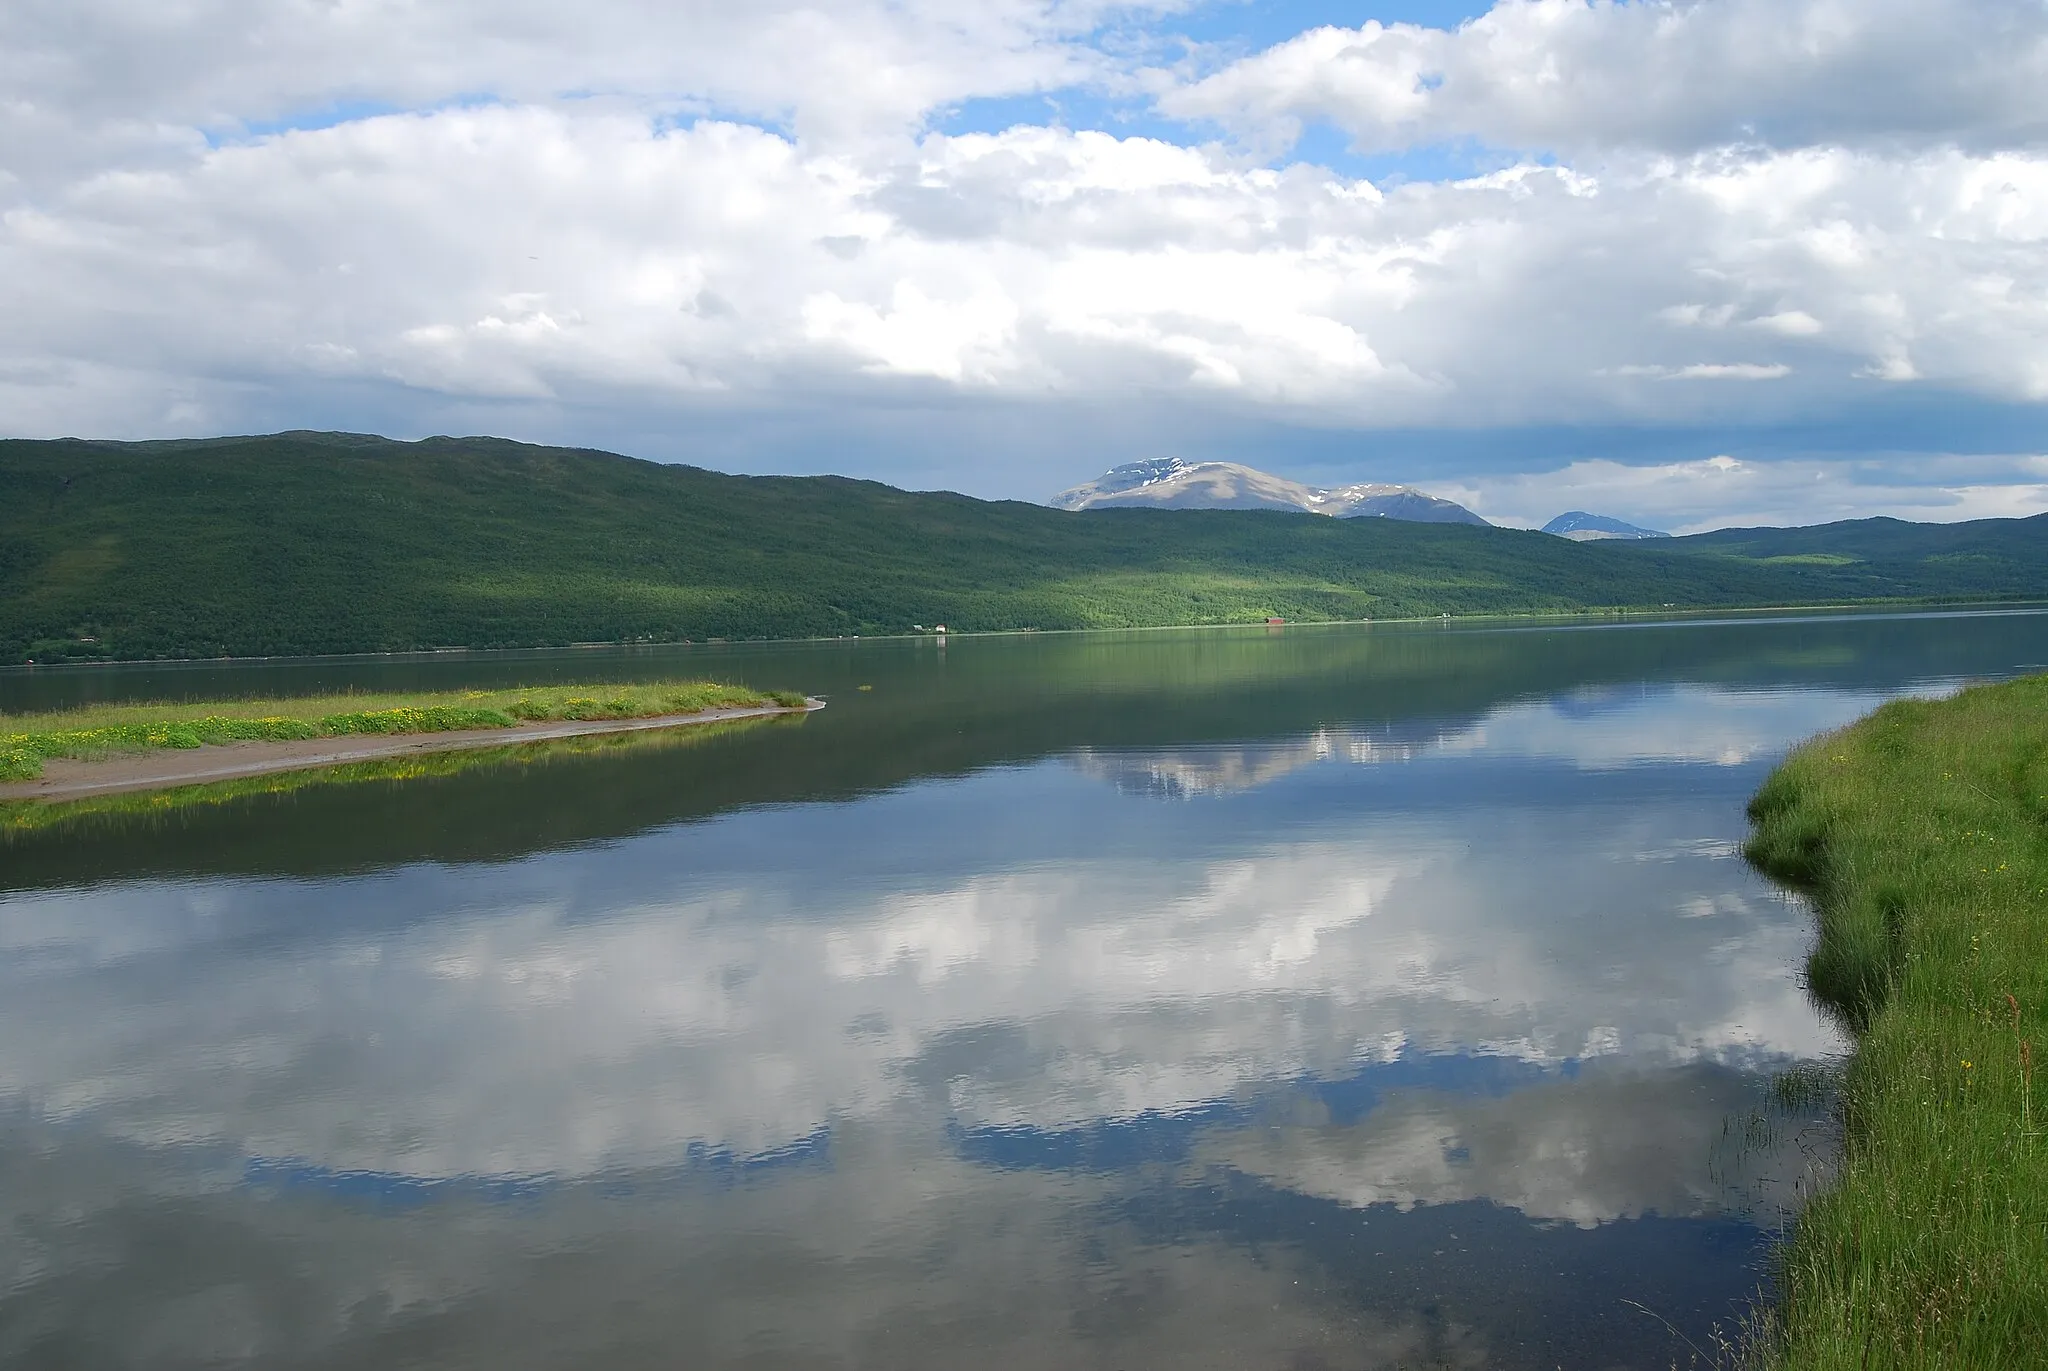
left=1749, top=676, right=2048, bottom=1371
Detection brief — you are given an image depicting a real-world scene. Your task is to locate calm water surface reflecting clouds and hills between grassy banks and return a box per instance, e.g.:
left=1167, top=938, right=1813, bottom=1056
left=0, top=615, right=2048, bottom=1371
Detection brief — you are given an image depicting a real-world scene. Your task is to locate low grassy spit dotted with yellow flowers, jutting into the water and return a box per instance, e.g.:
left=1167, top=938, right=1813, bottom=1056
left=0, top=680, right=803, bottom=781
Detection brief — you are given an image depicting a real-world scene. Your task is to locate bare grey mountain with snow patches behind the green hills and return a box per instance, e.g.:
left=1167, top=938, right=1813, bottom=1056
left=1047, top=457, right=1491, bottom=527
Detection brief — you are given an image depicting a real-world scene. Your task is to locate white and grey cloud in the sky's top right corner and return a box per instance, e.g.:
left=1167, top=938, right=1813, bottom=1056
left=1161, top=0, right=2048, bottom=154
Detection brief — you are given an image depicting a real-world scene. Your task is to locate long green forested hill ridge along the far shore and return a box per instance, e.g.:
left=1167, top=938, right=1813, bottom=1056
left=0, top=432, right=2048, bottom=662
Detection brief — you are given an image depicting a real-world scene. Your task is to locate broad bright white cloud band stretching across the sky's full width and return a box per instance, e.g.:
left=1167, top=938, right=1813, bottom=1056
left=0, top=107, right=2048, bottom=448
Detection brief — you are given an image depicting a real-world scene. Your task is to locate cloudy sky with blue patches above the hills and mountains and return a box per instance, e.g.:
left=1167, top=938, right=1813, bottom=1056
left=0, top=0, right=2048, bottom=531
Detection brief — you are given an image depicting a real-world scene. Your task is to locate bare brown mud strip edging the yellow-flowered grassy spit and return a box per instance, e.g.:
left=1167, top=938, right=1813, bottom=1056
left=0, top=697, right=825, bottom=803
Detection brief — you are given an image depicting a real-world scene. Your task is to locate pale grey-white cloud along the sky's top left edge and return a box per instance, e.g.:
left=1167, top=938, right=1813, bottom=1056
left=0, top=0, right=1180, bottom=147
